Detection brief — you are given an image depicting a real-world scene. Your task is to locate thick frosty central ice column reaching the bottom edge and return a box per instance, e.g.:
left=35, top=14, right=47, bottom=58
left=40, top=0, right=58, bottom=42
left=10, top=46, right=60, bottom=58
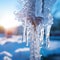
left=30, top=24, right=41, bottom=60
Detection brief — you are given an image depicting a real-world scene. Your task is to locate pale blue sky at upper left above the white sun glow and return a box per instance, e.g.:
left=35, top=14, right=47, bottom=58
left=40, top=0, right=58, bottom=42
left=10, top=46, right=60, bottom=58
left=0, top=0, right=17, bottom=19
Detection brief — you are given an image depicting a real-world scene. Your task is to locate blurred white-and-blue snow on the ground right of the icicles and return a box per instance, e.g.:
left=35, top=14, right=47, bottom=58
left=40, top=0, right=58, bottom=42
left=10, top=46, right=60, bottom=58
left=41, top=41, right=60, bottom=56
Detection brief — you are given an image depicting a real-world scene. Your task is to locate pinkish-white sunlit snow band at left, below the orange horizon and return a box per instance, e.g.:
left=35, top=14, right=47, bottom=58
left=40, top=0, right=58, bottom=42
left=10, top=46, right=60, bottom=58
left=0, top=36, right=22, bottom=45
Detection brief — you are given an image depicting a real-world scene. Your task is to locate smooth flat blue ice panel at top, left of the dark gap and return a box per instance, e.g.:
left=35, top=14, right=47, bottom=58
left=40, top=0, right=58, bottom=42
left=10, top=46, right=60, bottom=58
left=35, top=0, right=42, bottom=17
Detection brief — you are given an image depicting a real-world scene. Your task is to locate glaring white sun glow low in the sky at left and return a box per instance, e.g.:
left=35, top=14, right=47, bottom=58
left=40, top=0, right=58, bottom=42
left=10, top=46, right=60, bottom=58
left=0, top=13, right=22, bottom=29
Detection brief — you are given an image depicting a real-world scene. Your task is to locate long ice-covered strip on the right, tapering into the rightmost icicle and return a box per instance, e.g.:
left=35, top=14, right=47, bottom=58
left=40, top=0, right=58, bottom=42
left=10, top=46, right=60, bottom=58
left=42, top=0, right=56, bottom=47
